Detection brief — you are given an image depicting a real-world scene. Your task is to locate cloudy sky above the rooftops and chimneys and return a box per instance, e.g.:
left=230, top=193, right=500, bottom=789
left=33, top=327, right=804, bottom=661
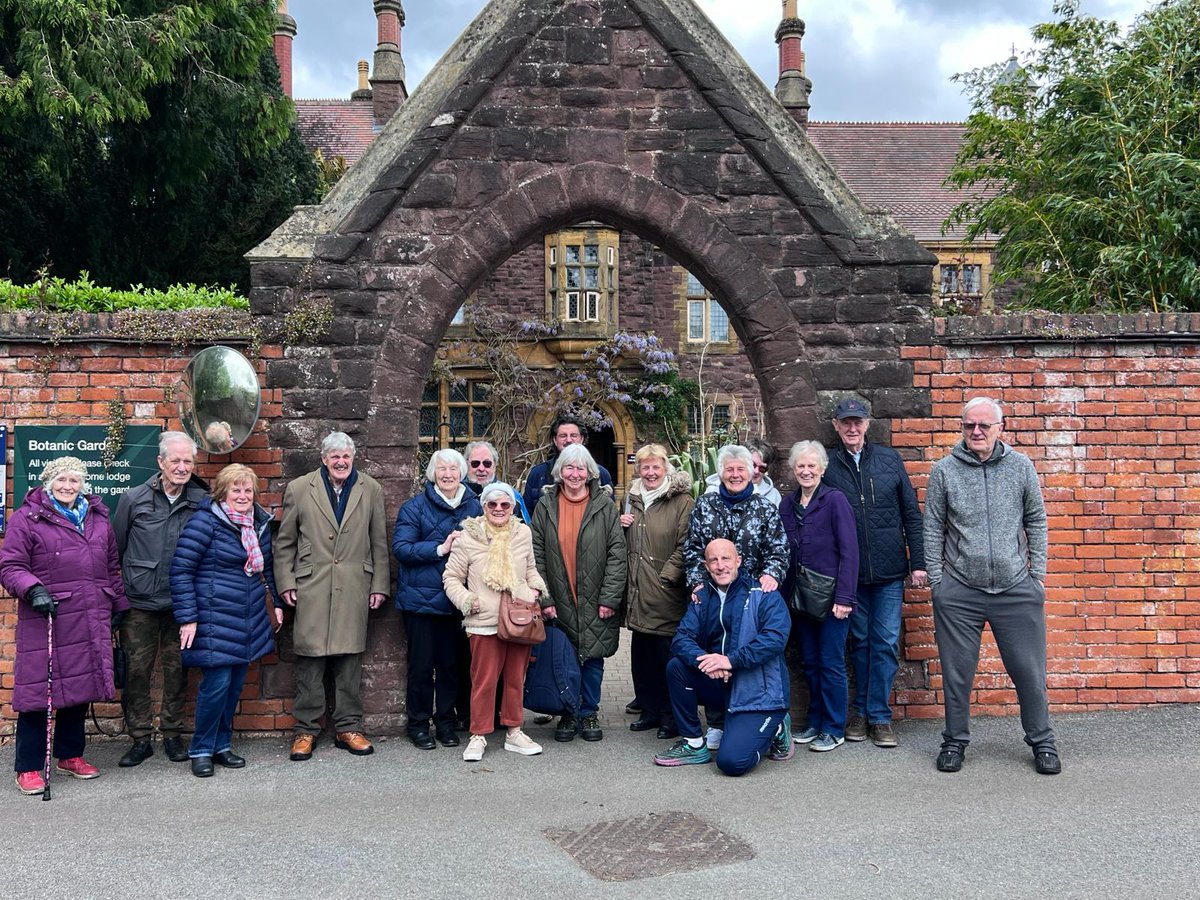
left=288, top=0, right=1152, bottom=121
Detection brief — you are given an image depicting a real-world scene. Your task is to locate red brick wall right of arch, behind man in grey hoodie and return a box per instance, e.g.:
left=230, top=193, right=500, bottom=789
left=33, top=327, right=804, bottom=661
left=892, top=316, right=1200, bottom=716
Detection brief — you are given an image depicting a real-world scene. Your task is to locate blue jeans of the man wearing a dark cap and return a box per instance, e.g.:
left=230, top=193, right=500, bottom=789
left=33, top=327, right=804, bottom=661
left=850, top=581, right=904, bottom=725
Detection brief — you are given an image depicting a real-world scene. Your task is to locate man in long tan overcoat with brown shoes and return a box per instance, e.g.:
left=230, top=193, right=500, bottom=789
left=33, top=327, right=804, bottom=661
left=275, top=431, right=391, bottom=761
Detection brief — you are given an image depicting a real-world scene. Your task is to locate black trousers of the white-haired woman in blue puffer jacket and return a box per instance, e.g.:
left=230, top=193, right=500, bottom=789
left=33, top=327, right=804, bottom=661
left=404, top=612, right=462, bottom=732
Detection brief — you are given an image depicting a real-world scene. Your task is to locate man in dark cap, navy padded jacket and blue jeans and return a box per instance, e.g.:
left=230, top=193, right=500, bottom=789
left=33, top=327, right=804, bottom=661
left=824, top=397, right=928, bottom=748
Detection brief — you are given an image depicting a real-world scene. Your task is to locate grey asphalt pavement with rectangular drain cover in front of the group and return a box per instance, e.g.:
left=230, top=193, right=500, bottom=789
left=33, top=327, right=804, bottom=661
left=0, top=706, right=1200, bottom=900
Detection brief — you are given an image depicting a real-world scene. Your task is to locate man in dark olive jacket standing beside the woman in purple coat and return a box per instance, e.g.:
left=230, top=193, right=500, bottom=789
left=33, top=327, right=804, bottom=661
left=113, top=431, right=209, bottom=768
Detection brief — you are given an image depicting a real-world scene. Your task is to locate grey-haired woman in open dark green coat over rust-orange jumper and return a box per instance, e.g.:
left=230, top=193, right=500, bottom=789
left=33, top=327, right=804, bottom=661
left=533, top=444, right=625, bottom=742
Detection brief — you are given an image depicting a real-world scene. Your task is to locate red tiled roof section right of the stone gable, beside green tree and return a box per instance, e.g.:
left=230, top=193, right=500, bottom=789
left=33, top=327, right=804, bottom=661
left=808, top=122, right=984, bottom=244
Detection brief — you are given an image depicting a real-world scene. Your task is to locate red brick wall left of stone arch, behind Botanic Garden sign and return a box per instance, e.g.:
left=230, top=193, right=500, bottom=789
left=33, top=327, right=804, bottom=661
left=0, top=326, right=285, bottom=737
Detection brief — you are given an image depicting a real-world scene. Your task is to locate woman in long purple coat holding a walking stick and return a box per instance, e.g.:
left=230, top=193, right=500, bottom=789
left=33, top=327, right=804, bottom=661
left=0, top=456, right=130, bottom=794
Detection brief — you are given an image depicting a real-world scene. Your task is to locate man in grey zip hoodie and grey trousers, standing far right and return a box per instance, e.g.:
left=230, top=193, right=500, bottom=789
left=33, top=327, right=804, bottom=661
left=925, top=397, right=1062, bottom=775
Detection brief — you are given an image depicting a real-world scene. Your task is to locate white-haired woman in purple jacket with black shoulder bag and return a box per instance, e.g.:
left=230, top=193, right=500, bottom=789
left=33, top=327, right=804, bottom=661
left=779, top=440, right=858, bottom=752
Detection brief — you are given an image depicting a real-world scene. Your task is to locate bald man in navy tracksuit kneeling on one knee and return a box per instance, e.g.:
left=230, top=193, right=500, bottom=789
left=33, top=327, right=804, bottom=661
left=654, top=540, right=794, bottom=775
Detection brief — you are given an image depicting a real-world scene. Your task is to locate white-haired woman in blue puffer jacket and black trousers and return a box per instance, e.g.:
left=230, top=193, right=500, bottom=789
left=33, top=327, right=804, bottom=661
left=391, top=450, right=484, bottom=750
